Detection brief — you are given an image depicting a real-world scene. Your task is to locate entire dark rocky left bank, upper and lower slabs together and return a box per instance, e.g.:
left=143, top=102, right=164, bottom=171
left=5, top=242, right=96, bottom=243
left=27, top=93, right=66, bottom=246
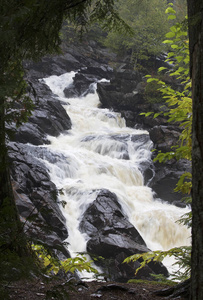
left=8, top=74, right=71, bottom=258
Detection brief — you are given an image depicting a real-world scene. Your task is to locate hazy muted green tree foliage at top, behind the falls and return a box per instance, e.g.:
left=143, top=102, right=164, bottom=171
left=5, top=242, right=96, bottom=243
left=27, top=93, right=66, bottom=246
left=105, top=0, right=168, bottom=66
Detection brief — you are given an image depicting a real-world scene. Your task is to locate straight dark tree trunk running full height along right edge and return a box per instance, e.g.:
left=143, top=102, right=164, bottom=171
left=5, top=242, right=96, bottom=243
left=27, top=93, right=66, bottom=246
left=188, top=0, right=203, bottom=300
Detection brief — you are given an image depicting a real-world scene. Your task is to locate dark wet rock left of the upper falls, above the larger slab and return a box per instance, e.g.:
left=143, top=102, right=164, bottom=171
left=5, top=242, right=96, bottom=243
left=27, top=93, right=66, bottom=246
left=12, top=76, right=71, bottom=145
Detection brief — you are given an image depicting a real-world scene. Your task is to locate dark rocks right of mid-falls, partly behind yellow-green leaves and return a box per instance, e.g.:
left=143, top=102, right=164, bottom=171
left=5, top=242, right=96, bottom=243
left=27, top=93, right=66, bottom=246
left=149, top=125, right=191, bottom=207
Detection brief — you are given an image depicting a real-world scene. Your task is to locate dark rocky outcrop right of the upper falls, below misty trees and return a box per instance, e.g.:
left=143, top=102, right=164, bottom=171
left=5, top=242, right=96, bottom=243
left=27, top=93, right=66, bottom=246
left=97, top=64, right=167, bottom=129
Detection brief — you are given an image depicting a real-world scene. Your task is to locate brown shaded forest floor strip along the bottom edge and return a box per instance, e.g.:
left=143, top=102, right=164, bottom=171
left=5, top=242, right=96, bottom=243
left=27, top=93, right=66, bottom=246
left=0, top=278, right=185, bottom=300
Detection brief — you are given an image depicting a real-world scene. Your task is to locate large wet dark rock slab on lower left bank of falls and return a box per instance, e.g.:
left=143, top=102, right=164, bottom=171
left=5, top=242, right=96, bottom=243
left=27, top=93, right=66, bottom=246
left=9, top=142, right=69, bottom=256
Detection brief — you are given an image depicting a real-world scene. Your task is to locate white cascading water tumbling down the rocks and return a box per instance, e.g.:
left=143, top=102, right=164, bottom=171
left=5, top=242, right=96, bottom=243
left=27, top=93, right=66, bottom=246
left=40, top=72, right=190, bottom=276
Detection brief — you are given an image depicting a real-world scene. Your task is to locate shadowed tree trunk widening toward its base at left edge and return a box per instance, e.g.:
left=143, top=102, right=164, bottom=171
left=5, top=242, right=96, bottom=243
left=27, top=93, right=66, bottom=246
left=0, top=99, right=26, bottom=256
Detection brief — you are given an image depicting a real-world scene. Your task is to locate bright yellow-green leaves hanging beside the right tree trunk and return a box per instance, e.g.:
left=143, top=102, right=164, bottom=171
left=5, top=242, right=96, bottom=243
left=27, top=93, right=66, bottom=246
left=142, top=6, right=192, bottom=194
